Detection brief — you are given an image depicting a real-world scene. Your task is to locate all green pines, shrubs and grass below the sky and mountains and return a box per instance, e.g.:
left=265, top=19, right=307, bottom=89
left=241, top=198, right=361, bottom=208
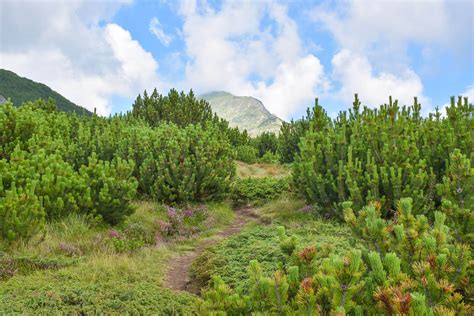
left=0, top=90, right=474, bottom=315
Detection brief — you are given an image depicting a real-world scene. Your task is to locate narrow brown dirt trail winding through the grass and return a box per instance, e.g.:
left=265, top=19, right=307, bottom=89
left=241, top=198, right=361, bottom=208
left=164, top=208, right=259, bottom=294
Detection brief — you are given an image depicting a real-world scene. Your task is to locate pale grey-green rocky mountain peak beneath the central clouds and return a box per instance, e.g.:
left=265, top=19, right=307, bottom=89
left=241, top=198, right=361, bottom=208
left=200, top=91, right=283, bottom=136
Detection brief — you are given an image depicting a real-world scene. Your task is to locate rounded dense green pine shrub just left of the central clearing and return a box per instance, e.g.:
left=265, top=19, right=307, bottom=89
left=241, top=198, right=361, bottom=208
left=137, top=124, right=235, bottom=204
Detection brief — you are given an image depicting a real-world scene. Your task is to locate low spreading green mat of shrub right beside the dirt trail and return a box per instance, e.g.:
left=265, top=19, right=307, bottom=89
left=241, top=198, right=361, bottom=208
left=190, top=216, right=360, bottom=292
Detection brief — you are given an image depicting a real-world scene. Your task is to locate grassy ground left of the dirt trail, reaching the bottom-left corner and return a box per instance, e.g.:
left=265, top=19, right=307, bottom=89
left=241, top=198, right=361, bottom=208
left=0, top=201, right=234, bottom=315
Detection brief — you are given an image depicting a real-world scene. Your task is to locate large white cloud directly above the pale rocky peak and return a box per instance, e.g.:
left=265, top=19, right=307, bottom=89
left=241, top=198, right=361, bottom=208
left=180, top=1, right=326, bottom=118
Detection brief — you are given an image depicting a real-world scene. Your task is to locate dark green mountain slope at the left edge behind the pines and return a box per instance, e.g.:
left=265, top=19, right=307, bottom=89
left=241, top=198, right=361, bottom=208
left=0, top=69, right=91, bottom=115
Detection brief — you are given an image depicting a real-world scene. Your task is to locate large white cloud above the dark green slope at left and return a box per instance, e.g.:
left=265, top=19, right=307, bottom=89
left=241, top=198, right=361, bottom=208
left=0, top=1, right=159, bottom=115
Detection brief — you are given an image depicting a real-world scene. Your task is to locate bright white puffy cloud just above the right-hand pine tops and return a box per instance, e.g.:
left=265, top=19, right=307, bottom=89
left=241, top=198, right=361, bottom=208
left=332, top=50, right=428, bottom=106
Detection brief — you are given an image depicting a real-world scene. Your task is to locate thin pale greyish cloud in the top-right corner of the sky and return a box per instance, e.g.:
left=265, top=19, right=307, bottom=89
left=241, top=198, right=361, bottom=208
left=310, top=0, right=473, bottom=71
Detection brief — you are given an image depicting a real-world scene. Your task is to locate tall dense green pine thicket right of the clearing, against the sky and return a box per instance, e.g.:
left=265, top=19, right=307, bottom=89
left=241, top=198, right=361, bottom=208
left=292, top=96, right=474, bottom=218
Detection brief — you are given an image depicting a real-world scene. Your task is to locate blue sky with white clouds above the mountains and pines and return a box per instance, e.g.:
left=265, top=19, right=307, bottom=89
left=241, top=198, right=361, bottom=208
left=0, top=0, right=474, bottom=120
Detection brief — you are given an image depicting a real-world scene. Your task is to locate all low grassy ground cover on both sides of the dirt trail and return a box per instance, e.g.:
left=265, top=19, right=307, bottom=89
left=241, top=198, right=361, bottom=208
left=0, top=183, right=356, bottom=315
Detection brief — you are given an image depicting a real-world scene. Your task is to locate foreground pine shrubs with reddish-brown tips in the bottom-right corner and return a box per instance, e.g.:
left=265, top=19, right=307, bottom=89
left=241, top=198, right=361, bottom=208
left=201, top=198, right=473, bottom=315
